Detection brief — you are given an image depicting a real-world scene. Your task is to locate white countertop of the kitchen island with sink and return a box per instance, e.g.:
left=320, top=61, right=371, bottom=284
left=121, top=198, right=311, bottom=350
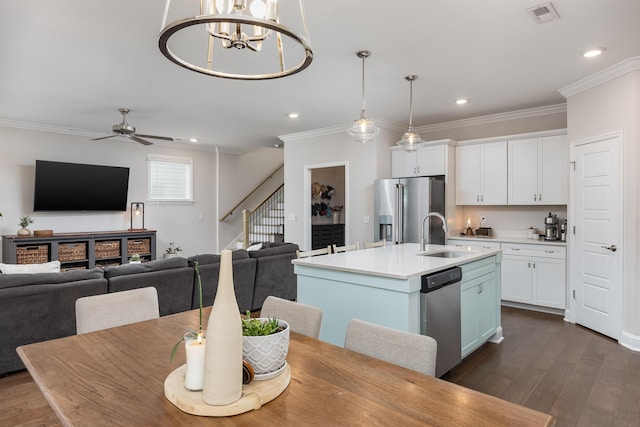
left=292, top=243, right=501, bottom=280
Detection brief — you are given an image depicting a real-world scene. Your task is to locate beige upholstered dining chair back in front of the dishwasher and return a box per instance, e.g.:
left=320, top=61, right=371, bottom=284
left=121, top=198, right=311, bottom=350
left=344, top=319, right=438, bottom=377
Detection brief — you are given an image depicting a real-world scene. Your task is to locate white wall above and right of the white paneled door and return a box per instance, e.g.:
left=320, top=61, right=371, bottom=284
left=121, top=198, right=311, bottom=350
left=567, top=71, right=640, bottom=342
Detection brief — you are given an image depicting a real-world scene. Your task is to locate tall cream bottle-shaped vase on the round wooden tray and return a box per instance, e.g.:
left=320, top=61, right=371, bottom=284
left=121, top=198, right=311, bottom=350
left=202, top=250, right=242, bottom=405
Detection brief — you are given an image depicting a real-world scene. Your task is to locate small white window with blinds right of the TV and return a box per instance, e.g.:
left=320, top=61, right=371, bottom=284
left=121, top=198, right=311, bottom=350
left=147, top=155, right=193, bottom=202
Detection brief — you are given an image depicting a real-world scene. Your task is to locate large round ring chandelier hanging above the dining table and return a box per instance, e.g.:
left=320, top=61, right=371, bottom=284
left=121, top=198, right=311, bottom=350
left=158, top=0, right=313, bottom=80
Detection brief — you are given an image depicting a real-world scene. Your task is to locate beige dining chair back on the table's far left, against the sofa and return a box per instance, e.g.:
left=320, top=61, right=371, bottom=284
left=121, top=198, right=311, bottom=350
left=76, top=286, right=160, bottom=334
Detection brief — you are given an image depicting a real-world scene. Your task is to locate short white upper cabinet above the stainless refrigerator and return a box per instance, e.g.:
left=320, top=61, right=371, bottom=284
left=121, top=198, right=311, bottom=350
left=391, top=144, right=446, bottom=178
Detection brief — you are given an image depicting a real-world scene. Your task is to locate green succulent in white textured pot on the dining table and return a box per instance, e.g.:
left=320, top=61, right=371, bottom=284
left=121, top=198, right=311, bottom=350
left=242, top=311, right=290, bottom=380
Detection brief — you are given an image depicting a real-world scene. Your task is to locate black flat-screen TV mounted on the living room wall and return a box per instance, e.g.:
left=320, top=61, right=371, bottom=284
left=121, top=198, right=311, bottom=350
left=33, top=160, right=129, bottom=211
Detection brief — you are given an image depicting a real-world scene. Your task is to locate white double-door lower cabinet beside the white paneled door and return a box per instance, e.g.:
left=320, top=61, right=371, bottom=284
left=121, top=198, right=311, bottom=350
left=502, top=243, right=566, bottom=309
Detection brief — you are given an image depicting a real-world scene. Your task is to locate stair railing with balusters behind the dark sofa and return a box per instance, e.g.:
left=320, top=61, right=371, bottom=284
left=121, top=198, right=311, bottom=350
left=242, top=184, right=284, bottom=249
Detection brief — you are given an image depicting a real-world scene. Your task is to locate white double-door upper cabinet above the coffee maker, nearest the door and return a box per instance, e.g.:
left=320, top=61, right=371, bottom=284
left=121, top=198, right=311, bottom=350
left=508, top=135, right=569, bottom=205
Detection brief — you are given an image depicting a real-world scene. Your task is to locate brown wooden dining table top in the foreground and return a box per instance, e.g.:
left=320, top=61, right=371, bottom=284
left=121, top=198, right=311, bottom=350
left=18, top=310, right=555, bottom=427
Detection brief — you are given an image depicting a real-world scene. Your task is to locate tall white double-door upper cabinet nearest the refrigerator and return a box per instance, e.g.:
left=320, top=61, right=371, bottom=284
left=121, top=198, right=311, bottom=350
left=456, top=141, right=507, bottom=205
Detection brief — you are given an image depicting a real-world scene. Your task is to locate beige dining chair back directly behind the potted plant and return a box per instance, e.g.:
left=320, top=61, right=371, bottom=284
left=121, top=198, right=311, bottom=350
left=260, top=296, right=322, bottom=338
